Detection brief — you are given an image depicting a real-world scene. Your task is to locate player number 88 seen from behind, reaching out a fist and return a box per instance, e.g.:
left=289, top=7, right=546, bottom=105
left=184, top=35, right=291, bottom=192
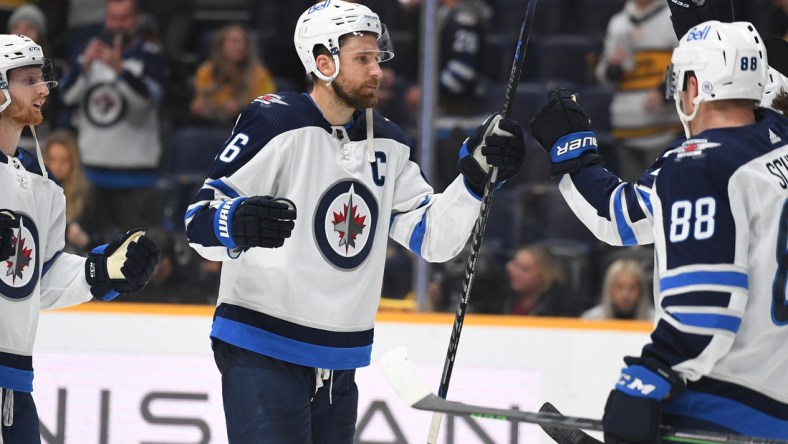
left=531, top=21, right=788, bottom=443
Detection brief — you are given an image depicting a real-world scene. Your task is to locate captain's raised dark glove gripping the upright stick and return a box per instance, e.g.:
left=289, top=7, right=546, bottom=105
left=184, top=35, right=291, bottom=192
left=457, top=114, right=525, bottom=196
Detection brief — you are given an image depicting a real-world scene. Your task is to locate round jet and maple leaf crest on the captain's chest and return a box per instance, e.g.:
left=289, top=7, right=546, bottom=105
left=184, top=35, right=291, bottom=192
left=314, top=180, right=378, bottom=270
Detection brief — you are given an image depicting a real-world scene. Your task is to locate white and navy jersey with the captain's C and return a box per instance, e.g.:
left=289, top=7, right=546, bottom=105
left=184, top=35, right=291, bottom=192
left=185, top=93, right=481, bottom=370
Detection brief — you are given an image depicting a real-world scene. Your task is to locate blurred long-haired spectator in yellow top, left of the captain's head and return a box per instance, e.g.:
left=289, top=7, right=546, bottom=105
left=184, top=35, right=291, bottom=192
left=191, top=24, right=276, bottom=126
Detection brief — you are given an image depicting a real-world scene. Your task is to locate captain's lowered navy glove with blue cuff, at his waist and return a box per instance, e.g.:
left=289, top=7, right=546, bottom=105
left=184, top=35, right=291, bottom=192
left=214, top=196, right=296, bottom=250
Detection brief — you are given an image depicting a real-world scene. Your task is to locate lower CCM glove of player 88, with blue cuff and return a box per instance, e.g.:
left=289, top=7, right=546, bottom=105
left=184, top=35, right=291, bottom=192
left=602, top=357, right=686, bottom=444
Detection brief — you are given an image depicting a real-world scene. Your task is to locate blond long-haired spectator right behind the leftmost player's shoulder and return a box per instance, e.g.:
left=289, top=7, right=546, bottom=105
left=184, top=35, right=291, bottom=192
left=44, top=129, right=93, bottom=254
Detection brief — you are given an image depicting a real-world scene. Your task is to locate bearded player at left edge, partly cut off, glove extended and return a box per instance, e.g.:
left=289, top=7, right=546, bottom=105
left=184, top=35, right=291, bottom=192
left=0, top=35, right=159, bottom=444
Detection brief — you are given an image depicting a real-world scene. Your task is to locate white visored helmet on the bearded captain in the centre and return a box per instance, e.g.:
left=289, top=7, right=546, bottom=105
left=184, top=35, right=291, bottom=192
left=293, top=0, right=394, bottom=83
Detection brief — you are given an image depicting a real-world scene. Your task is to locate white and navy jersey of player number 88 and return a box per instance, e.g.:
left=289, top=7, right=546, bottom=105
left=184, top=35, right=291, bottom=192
left=559, top=108, right=788, bottom=439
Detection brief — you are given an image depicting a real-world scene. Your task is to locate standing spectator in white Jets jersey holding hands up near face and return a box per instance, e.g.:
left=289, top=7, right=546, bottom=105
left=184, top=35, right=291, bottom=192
left=62, top=0, right=165, bottom=231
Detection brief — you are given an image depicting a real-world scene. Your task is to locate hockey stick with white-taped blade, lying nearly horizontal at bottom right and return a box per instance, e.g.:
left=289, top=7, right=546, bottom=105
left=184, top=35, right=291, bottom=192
left=380, top=347, right=788, bottom=444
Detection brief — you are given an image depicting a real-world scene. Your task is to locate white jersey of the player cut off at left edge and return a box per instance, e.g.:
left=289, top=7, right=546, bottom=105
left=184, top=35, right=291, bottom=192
left=0, top=148, right=92, bottom=392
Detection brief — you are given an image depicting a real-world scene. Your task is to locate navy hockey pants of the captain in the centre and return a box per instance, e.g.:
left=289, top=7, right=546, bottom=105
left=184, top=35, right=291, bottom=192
left=213, top=339, right=358, bottom=444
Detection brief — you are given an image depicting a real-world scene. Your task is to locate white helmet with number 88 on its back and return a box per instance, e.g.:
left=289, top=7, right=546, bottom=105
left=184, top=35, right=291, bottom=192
left=666, top=20, right=768, bottom=137
